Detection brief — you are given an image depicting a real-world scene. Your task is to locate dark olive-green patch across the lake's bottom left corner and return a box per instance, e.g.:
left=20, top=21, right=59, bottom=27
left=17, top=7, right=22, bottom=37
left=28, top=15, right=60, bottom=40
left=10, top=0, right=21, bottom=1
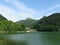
left=0, top=35, right=27, bottom=45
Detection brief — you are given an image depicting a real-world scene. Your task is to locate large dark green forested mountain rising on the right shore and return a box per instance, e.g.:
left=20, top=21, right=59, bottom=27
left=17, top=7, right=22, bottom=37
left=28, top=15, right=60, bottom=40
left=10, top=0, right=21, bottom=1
left=33, top=13, right=60, bottom=32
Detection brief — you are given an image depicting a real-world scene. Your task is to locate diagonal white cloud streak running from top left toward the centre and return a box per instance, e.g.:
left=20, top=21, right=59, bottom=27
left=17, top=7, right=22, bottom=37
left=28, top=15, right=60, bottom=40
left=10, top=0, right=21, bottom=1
left=12, top=0, right=37, bottom=14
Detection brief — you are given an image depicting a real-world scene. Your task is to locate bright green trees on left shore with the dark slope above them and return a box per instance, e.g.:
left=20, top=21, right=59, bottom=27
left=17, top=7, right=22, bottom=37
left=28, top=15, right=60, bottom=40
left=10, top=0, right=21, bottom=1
left=0, top=14, right=26, bottom=31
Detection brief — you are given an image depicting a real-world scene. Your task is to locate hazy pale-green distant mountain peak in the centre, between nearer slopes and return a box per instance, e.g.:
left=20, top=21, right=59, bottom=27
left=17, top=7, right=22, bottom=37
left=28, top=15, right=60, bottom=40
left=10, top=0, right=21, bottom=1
left=16, top=18, right=37, bottom=27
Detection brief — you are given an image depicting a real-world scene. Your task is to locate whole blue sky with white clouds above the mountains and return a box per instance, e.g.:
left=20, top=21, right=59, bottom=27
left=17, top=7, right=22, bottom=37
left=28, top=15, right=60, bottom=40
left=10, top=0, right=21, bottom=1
left=0, top=0, right=60, bottom=22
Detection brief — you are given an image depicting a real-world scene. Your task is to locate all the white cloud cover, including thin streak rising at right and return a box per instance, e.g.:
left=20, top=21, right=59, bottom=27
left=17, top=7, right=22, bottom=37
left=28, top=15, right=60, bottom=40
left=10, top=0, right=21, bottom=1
left=0, top=0, right=60, bottom=22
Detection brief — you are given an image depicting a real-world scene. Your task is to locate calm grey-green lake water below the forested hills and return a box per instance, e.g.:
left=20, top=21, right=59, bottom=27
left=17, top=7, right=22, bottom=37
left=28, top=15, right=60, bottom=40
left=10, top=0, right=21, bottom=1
left=2, top=32, right=60, bottom=45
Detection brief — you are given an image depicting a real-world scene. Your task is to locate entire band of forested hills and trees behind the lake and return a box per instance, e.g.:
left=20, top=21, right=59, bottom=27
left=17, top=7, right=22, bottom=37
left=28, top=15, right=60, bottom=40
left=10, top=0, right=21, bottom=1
left=0, top=13, right=60, bottom=32
